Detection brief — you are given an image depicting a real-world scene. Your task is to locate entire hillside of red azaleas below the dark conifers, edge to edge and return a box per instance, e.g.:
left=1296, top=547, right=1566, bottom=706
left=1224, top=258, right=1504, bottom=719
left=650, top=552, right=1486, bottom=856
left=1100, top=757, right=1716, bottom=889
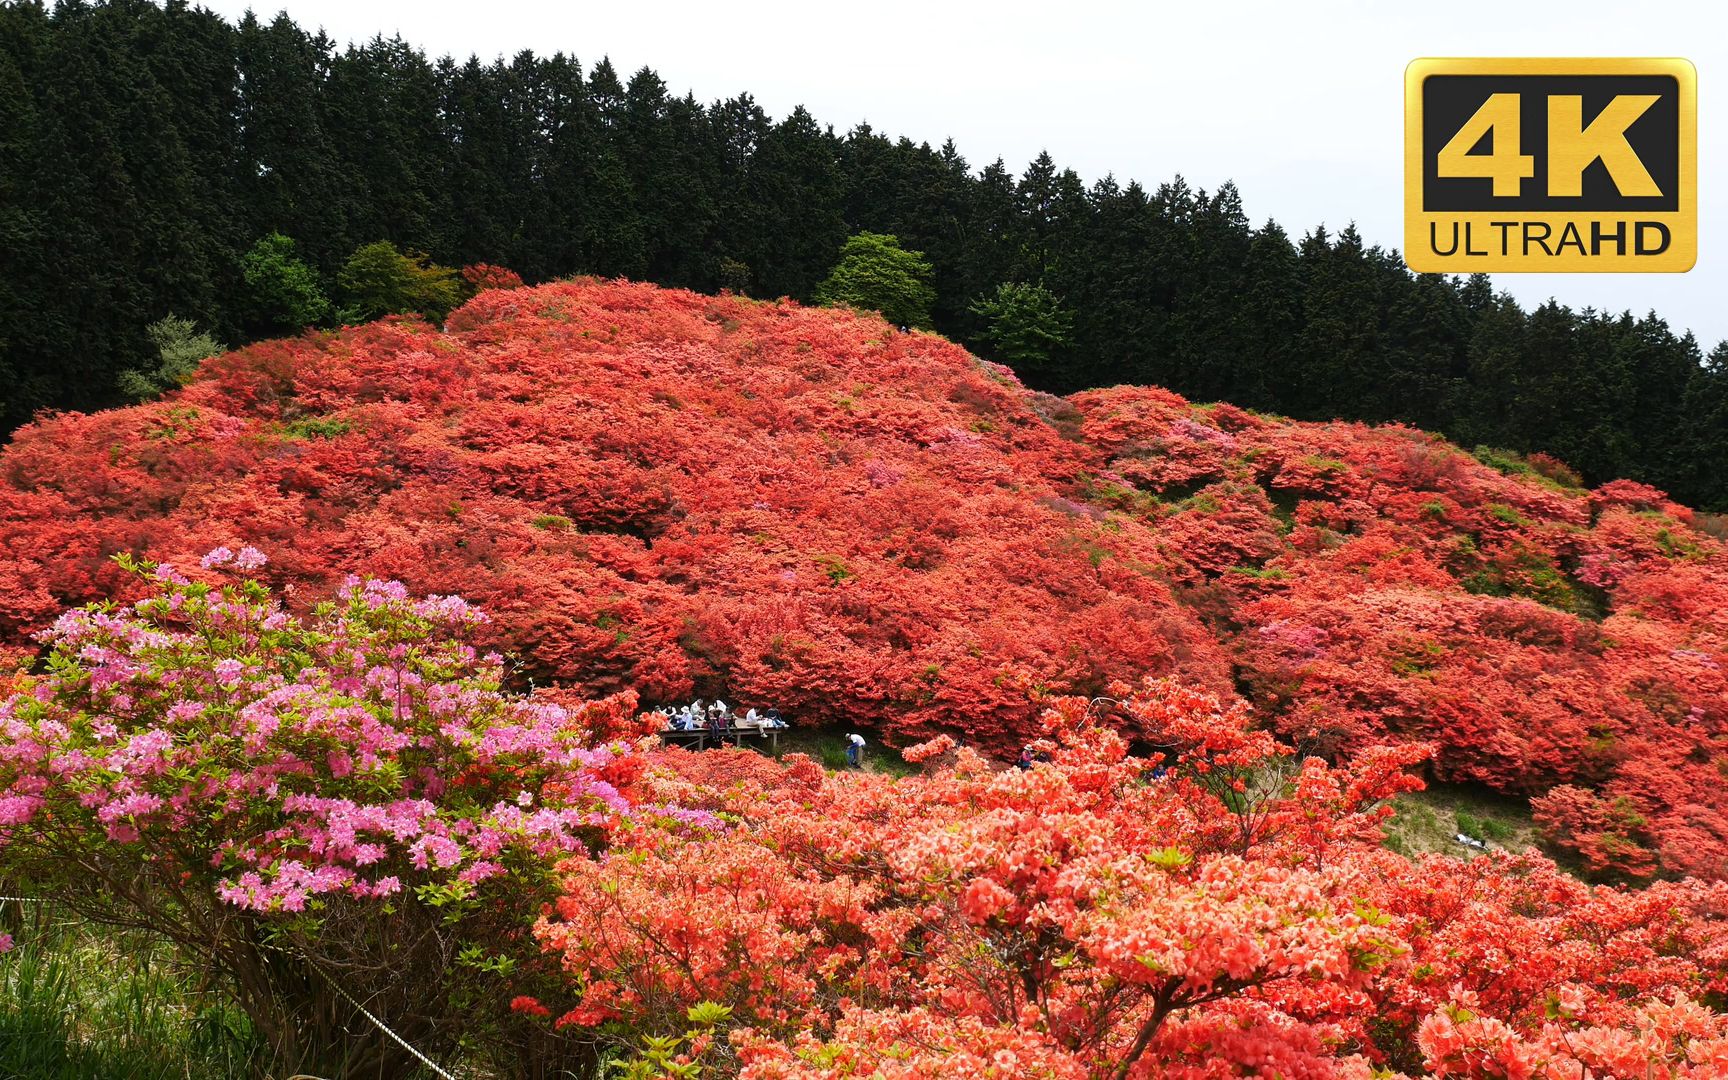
left=0, top=282, right=1728, bottom=878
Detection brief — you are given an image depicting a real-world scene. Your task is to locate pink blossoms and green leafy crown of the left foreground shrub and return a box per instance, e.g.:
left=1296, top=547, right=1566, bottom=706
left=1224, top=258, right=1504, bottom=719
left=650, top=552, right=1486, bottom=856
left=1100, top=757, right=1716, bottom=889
left=0, top=548, right=649, bottom=912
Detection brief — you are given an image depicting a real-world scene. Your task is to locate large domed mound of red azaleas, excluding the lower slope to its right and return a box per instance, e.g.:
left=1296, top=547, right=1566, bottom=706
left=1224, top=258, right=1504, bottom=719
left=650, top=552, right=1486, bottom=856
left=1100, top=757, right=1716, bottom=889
left=0, top=282, right=1229, bottom=746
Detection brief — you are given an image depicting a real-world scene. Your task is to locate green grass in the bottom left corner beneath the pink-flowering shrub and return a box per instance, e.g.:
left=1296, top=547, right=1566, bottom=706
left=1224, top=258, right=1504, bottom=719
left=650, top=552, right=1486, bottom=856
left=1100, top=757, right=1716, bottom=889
left=0, top=909, right=257, bottom=1080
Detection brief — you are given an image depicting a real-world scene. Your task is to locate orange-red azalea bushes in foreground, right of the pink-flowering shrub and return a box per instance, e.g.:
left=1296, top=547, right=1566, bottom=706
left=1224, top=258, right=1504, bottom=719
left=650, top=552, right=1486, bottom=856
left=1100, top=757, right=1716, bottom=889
left=518, top=683, right=1728, bottom=1080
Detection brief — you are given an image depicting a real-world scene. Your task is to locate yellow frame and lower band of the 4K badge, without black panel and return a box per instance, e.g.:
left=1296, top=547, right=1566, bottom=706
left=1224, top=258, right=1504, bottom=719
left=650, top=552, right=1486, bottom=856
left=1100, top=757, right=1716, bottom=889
left=1403, top=57, right=1699, bottom=273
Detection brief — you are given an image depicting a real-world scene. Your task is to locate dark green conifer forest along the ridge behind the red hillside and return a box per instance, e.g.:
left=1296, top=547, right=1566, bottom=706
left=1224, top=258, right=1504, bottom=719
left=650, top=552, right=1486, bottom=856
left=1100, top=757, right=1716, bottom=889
left=0, top=0, right=1728, bottom=510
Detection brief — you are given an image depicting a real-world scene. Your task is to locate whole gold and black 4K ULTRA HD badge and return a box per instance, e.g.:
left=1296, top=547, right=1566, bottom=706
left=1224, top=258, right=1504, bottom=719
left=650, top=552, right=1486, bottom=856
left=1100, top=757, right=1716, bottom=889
left=1405, top=59, right=1699, bottom=273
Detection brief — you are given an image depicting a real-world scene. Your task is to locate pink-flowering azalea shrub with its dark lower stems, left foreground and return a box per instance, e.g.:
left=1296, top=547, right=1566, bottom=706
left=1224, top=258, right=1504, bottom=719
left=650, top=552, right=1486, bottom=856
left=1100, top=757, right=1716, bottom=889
left=0, top=548, right=653, bottom=1075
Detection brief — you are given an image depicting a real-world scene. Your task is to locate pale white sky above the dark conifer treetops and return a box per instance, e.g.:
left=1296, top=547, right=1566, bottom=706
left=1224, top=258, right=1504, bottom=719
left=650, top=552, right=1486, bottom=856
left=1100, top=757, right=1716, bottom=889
left=204, top=0, right=1728, bottom=349
